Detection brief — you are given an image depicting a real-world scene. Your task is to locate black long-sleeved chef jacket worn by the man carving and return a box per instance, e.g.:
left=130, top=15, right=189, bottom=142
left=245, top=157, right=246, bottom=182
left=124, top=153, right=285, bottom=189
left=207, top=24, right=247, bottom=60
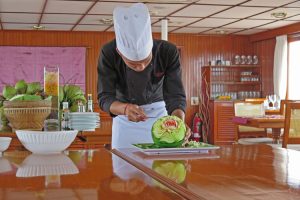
left=98, top=40, right=186, bottom=114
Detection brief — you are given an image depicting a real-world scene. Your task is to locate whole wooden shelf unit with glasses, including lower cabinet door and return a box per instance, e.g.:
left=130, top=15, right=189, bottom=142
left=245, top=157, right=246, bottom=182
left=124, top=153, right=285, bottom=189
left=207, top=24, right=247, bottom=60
left=201, top=65, right=262, bottom=144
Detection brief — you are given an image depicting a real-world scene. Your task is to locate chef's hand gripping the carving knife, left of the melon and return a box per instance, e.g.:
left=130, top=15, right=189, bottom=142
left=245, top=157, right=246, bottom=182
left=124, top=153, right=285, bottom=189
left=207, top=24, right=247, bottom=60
left=124, top=104, right=147, bottom=122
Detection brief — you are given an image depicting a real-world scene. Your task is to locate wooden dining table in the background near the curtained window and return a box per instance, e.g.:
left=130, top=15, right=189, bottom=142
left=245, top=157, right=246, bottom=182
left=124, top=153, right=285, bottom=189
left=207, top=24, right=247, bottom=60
left=233, top=115, right=284, bottom=144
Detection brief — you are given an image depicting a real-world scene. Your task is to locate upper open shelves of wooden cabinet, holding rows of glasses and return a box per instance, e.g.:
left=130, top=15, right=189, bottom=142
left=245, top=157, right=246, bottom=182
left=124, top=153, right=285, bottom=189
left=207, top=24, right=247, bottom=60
left=202, top=65, right=262, bottom=99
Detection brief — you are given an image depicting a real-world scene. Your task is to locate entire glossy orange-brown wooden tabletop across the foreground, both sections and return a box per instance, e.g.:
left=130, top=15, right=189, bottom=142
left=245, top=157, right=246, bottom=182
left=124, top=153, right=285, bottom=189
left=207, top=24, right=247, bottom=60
left=0, top=144, right=300, bottom=200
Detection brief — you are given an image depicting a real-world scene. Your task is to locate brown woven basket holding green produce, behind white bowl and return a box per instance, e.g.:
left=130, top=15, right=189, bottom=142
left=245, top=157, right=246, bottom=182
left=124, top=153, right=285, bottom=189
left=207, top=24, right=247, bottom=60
left=3, top=100, right=51, bottom=130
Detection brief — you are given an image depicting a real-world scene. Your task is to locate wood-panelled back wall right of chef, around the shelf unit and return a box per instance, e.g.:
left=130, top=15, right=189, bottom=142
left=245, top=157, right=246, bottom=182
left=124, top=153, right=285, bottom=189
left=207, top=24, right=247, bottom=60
left=169, top=34, right=253, bottom=124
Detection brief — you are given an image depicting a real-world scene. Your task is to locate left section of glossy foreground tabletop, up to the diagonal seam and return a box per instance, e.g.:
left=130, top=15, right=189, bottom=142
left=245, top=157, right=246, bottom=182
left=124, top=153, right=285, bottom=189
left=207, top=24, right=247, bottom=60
left=0, top=148, right=183, bottom=200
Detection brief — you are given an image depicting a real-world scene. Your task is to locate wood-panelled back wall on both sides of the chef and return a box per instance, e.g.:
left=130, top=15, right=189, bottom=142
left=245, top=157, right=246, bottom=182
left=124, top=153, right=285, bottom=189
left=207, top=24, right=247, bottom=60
left=0, top=31, right=253, bottom=125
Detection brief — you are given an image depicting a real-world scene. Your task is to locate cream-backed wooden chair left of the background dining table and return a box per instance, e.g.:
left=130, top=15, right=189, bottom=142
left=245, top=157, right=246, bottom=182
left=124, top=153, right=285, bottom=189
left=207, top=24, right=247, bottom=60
left=234, top=102, right=272, bottom=144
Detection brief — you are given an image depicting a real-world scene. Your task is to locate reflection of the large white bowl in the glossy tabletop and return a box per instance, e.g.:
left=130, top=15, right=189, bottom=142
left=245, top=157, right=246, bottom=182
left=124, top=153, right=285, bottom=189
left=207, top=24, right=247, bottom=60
left=16, top=154, right=79, bottom=177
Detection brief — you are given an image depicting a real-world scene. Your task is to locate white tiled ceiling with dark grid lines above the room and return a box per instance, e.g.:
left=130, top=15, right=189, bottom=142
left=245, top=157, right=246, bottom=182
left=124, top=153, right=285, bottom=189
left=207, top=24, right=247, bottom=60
left=0, top=0, right=300, bottom=35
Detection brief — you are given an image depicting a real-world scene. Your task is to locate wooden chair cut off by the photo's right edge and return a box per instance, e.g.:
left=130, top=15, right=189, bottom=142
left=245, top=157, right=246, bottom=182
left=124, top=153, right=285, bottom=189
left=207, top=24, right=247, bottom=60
left=282, top=101, right=300, bottom=148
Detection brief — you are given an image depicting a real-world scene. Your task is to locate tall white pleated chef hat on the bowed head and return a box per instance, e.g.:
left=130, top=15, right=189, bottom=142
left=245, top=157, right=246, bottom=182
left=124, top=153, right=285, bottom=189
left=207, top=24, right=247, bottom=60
left=113, top=3, right=153, bottom=61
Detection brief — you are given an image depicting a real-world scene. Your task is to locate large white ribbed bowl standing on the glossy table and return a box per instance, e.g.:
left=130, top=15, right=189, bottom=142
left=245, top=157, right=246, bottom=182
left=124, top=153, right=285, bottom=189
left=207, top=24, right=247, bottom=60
left=16, top=130, right=78, bottom=154
